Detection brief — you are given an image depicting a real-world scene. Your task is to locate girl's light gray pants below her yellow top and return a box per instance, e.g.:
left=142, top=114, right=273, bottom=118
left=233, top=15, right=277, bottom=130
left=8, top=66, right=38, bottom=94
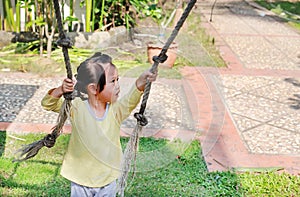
left=71, top=181, right=117, bottom=197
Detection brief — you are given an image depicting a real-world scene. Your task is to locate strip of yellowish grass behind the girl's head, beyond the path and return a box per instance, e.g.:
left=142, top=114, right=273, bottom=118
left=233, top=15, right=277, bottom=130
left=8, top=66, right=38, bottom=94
left=0, top=43, right=199, bottom=79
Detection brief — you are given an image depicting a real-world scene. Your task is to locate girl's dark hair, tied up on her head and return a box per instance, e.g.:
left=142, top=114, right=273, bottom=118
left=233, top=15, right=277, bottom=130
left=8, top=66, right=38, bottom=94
left=75, top=52, right=115, bottom=98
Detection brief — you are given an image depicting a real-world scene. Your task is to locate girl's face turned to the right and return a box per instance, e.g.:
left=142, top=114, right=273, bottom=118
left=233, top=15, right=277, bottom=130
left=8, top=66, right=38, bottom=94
left=98, top=64, right=120, bottom=103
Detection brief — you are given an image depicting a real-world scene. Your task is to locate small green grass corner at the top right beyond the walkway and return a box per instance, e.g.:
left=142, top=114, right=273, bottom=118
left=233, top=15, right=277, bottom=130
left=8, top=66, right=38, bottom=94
left=255, top=0, right=300, bottom=31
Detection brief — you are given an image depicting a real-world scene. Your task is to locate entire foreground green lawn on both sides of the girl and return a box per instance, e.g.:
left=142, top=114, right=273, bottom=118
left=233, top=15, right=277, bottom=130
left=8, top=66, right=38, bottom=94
left=0, top=132, right=300, bottom=197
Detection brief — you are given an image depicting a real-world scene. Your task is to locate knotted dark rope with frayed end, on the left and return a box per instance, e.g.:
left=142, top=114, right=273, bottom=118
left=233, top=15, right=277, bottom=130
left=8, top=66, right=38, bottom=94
left=14, top=0, right=73, bottom=161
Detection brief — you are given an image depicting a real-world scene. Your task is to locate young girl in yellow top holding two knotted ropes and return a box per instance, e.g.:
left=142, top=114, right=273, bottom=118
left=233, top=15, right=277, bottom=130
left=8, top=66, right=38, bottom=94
left=42, top=53, right=157, bottom=197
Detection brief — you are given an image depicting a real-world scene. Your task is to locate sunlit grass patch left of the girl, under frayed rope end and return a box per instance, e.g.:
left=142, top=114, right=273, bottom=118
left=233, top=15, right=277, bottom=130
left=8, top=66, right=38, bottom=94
left=0, top=132, right=70, bottom=196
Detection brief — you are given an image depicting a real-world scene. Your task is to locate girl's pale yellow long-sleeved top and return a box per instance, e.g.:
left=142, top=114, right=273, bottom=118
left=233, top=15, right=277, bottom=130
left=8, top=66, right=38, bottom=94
left=42, top=86, right=142, bottom=187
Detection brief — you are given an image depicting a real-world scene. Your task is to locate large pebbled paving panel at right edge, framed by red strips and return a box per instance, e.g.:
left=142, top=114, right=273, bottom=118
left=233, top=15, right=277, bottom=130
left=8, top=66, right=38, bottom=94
left=219, top=75, right=300, bottom=155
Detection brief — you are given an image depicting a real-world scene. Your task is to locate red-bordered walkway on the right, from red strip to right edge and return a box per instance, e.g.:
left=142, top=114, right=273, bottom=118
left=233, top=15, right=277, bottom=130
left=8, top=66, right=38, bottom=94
left=191, top=0, right=300, bottom=174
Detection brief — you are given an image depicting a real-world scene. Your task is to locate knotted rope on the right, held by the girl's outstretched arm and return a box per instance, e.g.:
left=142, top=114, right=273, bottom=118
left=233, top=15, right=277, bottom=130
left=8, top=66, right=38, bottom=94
left=118, top=0, right=196, bottom=197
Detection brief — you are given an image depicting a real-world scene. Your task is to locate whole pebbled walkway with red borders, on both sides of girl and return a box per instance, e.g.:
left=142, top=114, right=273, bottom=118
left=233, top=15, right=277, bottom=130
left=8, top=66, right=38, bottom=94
left=0, top=0, right=300, bottom=174
